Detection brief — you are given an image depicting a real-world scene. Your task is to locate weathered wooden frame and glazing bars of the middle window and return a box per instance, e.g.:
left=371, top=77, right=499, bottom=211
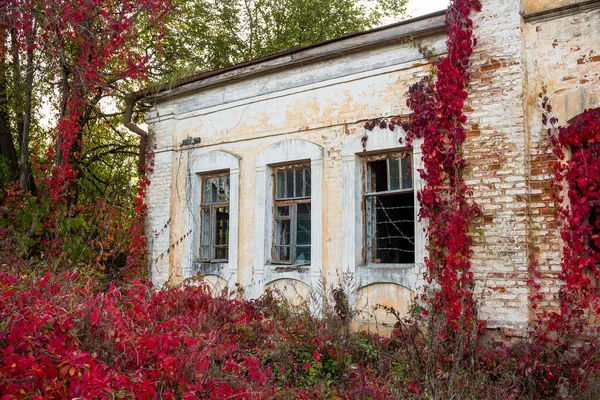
left=271, top=163, right=312, bottom=266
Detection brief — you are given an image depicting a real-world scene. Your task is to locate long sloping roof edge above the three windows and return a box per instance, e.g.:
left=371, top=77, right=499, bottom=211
left=135, top=10, right=446, bottom=102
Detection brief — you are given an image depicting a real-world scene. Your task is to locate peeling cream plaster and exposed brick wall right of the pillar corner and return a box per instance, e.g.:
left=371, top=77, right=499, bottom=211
left=523, top=2, right=600, bottom=318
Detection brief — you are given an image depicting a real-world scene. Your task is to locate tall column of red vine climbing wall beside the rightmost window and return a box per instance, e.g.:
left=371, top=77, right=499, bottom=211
left=403, top=0, right=481, bottom=336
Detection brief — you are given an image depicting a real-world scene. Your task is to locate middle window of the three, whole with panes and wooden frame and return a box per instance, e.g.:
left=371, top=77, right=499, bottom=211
left=272, top=165, right=311, bottom=265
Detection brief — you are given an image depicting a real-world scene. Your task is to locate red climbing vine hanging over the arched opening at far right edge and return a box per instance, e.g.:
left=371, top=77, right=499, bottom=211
left=542, top=104, right=600, bottom=334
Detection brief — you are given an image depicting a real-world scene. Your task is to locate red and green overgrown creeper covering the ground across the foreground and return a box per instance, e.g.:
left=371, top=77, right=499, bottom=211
left=0, top=273, right=600, bottom=399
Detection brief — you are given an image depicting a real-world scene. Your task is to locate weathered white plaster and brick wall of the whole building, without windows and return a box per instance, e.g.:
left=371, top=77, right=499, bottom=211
left=142, top=0, right=600, bottom=334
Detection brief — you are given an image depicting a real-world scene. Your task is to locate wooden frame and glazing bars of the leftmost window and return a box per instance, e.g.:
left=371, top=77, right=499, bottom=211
left=197, top=171, right=231, bottom=263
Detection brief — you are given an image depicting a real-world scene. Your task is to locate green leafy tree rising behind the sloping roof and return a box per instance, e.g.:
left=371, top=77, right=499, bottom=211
left=154, top=0, right=408, bottom=80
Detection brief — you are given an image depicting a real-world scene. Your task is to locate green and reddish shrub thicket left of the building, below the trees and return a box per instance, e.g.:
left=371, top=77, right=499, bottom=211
left=0, top=184, right=146, bottom=287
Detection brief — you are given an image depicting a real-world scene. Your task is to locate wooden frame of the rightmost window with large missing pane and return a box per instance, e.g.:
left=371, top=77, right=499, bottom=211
left=360, top=149, right=417, bottom=266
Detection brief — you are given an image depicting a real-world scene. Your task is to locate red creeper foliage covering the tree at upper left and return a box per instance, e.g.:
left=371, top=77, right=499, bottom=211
left=0, top=0, right=171, bottom=202
